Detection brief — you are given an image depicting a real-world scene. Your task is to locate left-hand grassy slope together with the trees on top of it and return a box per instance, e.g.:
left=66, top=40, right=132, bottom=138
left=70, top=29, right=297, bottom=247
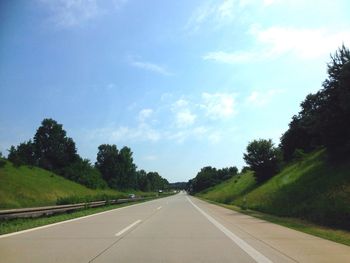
left=0, top=119, right=169, bottom=208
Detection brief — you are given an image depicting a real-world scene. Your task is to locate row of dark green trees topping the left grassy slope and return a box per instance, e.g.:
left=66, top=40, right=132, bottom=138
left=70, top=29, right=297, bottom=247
left=7, top=119, right=169, bottom=191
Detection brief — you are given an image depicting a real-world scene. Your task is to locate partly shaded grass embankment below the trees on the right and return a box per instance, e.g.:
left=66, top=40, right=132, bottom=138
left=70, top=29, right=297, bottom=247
left=198, top=151, right=350, bottom=245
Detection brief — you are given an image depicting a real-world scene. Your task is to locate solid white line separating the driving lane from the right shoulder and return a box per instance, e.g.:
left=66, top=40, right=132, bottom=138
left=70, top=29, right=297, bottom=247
left=186, top=196, right=272, bottom=263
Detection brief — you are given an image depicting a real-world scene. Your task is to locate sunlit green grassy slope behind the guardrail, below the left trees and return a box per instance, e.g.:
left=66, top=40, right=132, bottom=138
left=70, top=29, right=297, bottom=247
left=0, top=162, right=125, bottom=209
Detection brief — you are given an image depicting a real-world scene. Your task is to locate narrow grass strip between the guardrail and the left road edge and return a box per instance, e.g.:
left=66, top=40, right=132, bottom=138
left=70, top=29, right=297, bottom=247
left=0, top=195, right=161, bottom=235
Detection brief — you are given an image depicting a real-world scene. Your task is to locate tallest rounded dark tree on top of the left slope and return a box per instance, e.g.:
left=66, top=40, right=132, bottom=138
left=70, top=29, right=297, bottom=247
left=34, top=119, right=78, bottom=173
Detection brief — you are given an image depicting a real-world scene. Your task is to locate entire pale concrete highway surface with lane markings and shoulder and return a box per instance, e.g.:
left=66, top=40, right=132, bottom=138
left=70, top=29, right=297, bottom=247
left=0, top=193, right=350, bottom=263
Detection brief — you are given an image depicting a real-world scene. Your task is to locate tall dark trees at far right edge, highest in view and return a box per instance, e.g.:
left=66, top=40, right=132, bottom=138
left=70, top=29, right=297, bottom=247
left=280, top=45, right=350, bottom=161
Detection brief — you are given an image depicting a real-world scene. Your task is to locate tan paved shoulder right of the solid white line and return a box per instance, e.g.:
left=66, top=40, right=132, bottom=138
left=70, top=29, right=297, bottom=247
left=191, top=197, right=350, bottom=262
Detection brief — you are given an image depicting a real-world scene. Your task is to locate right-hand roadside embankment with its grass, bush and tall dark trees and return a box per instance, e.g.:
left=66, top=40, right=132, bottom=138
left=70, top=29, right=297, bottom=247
left=187, top=45, right=350, bottom=239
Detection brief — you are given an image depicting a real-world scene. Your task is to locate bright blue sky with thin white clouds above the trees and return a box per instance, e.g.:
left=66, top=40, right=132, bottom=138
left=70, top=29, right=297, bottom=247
left=0, top=0, right=350, bottom=182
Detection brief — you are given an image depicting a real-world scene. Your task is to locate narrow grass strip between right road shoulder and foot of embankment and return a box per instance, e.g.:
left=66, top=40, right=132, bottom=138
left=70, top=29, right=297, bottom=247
left=201, top=198, right=350, bottom=246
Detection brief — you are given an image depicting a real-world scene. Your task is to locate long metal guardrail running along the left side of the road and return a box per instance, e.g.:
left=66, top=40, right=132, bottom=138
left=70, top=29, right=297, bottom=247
left=0, top=197, right=149, bottom=220
